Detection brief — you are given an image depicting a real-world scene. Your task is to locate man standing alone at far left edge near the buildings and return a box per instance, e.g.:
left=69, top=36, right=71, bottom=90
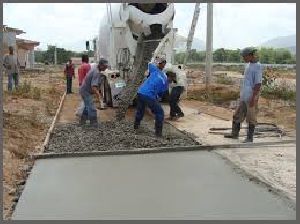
left=3, top=46, right=20, bottom=92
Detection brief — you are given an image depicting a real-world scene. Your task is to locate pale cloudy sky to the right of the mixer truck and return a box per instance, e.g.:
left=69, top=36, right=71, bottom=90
left=175, top=3, right=296, bottom=48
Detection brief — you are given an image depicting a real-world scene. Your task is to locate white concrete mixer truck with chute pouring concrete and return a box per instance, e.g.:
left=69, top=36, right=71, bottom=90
left=96, top=3, right=175, bottom=119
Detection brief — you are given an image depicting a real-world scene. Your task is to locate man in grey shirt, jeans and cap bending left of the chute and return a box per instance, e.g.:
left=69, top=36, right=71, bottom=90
left=79, top=59, right=108, bottom=126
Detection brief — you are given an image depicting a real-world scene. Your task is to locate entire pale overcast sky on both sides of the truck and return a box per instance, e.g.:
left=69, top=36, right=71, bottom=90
left=3, top=3, right=296, bottom=50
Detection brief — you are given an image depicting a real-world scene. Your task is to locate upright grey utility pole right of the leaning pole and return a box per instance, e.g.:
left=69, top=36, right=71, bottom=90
left=205, top=3, right=213, bottom=95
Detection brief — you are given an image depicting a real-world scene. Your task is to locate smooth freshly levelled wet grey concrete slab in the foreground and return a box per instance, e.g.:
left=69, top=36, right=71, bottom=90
left=13, top=151, right=296, bottom=220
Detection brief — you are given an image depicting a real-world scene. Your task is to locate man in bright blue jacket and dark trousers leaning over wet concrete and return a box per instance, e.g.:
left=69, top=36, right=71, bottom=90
left=134, top=57, right=168, bottom=137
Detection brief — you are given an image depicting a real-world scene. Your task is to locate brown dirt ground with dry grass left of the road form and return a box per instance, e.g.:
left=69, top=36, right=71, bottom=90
left=3, top=70, right=65, bottom=219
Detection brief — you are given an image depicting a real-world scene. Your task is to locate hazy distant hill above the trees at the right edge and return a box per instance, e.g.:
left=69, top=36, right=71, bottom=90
left=260, top=34, right=296, bottom=54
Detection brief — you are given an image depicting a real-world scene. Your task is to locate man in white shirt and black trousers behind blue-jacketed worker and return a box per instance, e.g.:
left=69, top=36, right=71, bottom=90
left=169, top=65, right=186, bottom=120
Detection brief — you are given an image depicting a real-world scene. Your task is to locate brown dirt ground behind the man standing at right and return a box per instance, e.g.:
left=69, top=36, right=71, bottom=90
left=188, top=84, right=296, bottom=132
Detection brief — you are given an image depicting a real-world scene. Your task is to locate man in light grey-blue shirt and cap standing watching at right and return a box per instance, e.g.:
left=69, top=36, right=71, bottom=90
left=224, top=47, right=262, bottom=143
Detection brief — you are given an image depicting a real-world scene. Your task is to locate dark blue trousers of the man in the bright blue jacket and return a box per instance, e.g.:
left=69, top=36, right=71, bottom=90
left=135, top=94, right=164, bottom=127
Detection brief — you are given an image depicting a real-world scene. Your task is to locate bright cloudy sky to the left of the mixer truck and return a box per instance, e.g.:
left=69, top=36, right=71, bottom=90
left=4, top=3, right=105, bottom=50
